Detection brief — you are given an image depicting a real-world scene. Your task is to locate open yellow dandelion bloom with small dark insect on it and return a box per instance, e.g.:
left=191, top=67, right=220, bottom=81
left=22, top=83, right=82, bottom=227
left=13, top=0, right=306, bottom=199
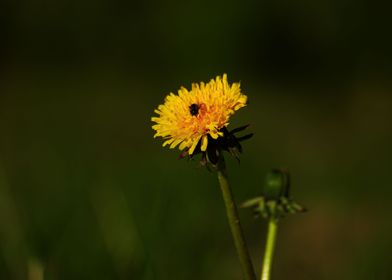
left=151, top=74, right=247, bottom=155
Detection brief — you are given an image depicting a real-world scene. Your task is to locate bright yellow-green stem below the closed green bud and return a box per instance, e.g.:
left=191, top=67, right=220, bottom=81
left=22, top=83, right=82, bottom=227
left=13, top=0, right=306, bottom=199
left=261, top=218, right=278, bottom=280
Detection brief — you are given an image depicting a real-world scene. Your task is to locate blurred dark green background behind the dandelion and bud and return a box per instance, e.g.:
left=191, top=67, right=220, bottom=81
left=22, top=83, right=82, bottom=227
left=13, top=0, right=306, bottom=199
left=0, top=0, right=392, bottom=280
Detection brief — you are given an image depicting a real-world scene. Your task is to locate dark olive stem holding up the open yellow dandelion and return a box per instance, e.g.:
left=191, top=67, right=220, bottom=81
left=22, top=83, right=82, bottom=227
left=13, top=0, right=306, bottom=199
left=217, top=157, right=256, bottom=280
